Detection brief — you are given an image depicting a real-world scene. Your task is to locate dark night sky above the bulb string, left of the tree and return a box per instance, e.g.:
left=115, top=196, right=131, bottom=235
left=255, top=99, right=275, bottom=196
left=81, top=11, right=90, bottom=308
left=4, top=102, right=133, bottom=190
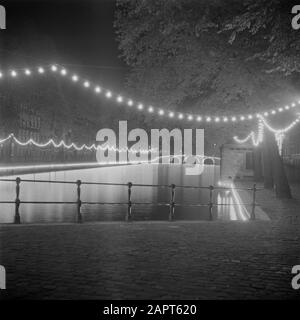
left=0, top=0, right=126, bottom=89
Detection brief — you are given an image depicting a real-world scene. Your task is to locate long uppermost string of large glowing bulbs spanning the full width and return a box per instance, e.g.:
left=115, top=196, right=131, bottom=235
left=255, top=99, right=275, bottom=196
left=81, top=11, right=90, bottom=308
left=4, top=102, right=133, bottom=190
left=0, top=64, right=300, bottom=124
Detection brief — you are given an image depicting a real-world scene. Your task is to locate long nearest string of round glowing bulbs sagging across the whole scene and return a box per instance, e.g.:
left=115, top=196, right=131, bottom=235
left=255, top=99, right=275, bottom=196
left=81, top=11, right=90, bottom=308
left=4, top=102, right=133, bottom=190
left=0, top=65, right=300, bottom=123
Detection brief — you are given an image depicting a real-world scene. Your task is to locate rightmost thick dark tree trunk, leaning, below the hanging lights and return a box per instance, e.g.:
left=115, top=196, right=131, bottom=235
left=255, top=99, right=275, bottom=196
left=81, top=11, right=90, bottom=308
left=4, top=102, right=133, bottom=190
left=265, top=130, right=292, bottom=199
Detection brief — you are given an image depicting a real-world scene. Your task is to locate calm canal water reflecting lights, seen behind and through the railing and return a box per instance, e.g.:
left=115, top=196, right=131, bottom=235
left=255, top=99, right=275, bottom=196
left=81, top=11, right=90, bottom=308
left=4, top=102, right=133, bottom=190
left=0, top=164, right=248, bottom=223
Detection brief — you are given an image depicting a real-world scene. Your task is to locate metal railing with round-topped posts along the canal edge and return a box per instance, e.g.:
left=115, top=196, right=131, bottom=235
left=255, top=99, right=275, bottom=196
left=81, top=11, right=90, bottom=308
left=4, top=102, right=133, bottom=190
left=0, top=177, right=262, bottom=224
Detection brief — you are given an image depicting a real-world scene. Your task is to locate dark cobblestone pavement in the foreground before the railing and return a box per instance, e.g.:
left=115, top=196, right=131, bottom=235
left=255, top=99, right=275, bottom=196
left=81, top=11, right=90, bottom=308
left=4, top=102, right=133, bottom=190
left=0, top=185, right=300, bottom=299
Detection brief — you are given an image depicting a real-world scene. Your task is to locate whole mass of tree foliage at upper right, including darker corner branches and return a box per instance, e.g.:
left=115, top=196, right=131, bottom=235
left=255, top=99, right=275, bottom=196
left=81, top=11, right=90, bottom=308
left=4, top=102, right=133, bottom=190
left=115, top=0, right=299, bottom=196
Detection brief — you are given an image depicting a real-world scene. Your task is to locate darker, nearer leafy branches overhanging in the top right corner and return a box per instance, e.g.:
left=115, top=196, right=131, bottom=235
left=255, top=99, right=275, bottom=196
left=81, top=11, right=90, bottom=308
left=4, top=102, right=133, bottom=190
left=218, top=0, right=300, bottom=75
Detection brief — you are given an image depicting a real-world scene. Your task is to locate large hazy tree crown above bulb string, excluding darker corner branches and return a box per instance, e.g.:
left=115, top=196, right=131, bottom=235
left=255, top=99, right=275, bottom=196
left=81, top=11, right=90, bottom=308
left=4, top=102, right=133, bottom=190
left=115, top=0, right=297, bottom=131
